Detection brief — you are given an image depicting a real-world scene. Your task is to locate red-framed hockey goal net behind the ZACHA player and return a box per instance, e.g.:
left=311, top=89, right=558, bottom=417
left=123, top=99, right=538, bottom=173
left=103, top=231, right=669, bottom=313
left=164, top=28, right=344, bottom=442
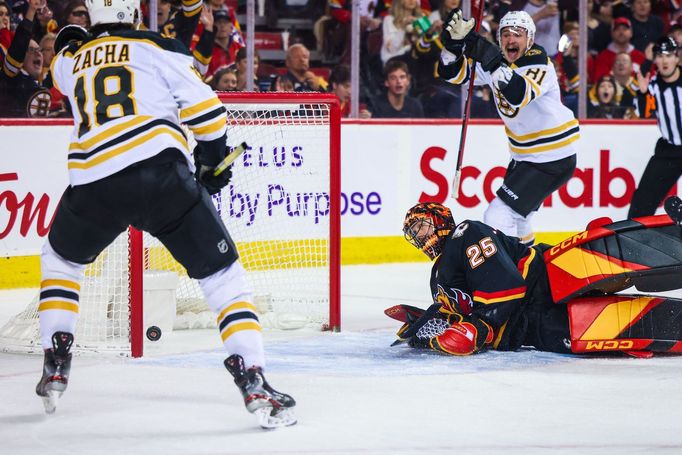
left=0, top=93, right=340, bottom=357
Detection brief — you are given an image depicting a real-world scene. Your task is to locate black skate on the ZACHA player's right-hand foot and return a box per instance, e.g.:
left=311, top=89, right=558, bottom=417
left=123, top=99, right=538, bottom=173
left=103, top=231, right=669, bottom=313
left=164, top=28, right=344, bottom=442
left=224, top=354, right=296, bottom=429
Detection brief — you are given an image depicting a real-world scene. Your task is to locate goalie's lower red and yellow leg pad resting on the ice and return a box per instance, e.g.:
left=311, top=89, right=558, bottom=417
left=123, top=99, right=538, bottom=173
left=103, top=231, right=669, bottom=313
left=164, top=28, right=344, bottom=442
left=568, top=294, right=682, bottom=353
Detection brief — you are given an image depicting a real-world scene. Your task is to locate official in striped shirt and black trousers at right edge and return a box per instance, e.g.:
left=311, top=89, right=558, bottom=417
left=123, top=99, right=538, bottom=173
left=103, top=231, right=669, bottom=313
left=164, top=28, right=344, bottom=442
left=628, top=36, right=682, bottom=218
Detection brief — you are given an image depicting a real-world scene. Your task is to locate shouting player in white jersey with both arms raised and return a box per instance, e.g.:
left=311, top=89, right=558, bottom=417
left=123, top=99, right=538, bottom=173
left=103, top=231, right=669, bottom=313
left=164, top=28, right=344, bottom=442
left=439, top=9, right=580, bottom=245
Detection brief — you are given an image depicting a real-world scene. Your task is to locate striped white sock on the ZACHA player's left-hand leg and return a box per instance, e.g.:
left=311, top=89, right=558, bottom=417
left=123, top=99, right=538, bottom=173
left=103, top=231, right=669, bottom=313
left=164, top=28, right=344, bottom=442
left=38, top=240, right=85, bottom=349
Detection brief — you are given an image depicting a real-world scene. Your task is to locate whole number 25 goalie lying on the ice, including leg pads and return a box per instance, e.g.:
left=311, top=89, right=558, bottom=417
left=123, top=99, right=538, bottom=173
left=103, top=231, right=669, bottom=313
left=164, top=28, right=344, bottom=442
left=385, top=201, right=682, bottom=357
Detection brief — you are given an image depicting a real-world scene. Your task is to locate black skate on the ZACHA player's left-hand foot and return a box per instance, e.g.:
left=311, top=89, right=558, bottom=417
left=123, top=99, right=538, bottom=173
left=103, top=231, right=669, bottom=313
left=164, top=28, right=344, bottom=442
left=36, top=332, right=73, bottom=414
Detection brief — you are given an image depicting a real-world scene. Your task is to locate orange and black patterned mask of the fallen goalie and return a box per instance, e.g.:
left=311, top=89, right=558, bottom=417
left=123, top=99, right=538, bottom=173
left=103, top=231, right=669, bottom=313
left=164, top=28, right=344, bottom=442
left=403, top=202, right=455, bottom=260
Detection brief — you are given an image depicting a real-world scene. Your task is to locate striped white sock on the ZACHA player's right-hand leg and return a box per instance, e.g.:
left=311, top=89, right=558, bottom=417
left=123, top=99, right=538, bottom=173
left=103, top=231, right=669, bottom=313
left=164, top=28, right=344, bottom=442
left=199, top=262, right=265, bottom=368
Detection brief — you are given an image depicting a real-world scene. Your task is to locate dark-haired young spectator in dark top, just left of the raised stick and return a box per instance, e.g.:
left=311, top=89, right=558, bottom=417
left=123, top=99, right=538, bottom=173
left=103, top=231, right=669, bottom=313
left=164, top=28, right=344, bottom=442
left=372, top=58, right=424, bottom=118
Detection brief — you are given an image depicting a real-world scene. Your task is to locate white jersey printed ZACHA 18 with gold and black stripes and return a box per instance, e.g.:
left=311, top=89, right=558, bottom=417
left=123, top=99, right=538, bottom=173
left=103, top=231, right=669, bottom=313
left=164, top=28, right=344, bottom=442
left=51, top=30, right=226, bottom=186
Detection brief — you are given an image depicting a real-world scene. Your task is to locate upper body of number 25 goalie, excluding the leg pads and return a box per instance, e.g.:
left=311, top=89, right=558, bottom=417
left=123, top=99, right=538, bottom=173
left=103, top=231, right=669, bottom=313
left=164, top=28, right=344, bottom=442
left=398, top=203, right=570, bottom=355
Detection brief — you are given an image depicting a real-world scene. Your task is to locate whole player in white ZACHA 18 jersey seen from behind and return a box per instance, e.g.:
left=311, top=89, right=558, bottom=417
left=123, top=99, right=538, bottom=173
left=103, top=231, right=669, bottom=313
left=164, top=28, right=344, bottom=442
left=36, top=0, right=296, bottom=428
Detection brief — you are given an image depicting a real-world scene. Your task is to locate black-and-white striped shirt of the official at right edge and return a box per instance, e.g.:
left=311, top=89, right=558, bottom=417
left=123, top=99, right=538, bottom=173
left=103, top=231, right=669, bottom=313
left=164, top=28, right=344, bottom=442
left=649, top=74, right=682, bottom=146
